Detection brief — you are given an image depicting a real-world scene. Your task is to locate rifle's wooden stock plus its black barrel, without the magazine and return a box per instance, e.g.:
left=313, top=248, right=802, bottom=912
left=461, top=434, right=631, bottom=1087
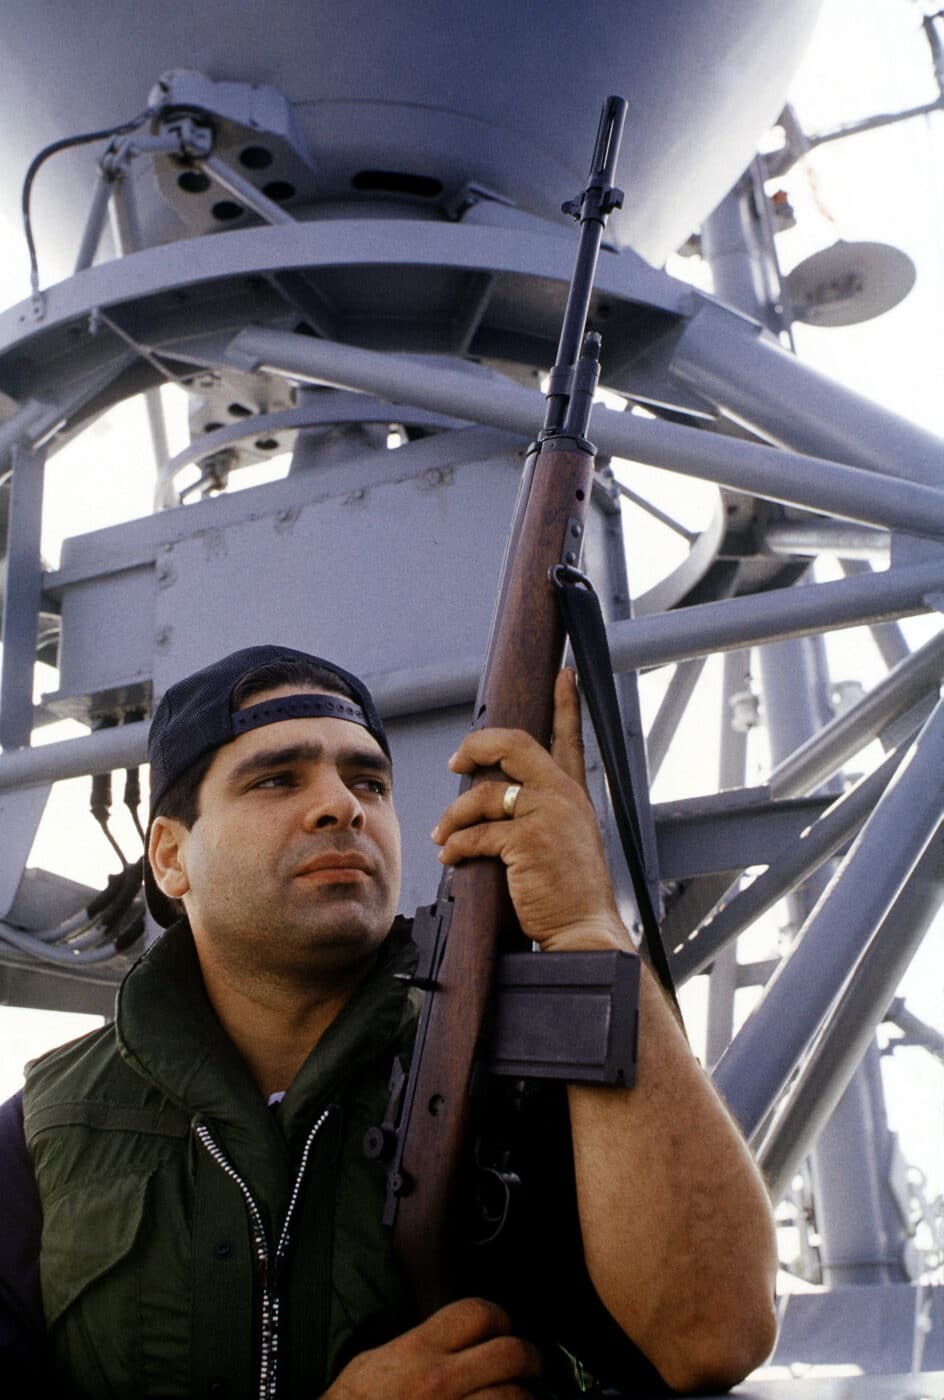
left=378, top=98, right=626, bottom=1315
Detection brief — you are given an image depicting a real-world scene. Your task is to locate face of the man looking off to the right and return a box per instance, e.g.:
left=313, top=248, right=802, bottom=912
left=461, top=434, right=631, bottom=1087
left=156, top=686, right=401, bottom=977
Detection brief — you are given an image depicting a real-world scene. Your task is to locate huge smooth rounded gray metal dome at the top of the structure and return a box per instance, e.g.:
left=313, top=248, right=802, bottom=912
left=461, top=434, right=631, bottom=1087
left=0, top=0, right=819, bottom=273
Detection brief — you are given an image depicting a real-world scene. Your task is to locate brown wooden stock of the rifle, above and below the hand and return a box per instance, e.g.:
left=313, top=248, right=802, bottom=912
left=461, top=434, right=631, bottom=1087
left=394, top=448, right=594, bottom=1313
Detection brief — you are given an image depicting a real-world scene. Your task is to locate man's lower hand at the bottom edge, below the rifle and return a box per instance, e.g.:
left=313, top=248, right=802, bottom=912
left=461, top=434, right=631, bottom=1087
left=324, top=1298, right=542, bottom=1400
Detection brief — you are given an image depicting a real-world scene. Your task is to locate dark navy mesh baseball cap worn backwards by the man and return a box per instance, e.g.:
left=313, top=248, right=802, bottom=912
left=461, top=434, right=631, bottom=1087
left=144, top=647, right=391, bottom=927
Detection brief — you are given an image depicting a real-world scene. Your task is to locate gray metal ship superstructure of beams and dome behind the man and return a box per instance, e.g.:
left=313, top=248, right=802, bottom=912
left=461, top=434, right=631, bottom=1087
left=0, top=0, right=944, bottom=1400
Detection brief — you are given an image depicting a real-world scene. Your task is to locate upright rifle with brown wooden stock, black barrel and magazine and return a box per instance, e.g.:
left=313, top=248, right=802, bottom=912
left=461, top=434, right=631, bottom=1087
left=364, top=97, right=639, bottom=1315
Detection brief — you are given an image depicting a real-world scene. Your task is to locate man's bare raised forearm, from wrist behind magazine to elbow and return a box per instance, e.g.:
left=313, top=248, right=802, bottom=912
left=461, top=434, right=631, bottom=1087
left=569, top=967, right=777, bottom=1390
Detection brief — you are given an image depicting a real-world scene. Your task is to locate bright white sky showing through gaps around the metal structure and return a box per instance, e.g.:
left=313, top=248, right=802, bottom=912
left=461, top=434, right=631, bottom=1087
left=0, top=0, right=944, bottom=1282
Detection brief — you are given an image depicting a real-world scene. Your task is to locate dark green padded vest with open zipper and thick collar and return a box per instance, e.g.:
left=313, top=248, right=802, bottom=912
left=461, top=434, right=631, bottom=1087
left=24, top=920, right=416, bottom=1400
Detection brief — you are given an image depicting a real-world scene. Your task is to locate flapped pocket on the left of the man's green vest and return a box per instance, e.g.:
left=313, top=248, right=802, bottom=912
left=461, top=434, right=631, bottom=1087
left=41, top=1172, right=153, bottom=1396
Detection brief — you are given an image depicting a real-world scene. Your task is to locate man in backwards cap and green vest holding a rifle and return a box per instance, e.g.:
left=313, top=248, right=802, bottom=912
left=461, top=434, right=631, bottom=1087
left=0, top=647, right=776, bottom=1400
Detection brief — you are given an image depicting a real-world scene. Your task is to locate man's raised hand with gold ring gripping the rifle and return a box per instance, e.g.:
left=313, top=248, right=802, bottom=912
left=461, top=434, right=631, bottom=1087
left=433, top=671, right=633, bottom=952
